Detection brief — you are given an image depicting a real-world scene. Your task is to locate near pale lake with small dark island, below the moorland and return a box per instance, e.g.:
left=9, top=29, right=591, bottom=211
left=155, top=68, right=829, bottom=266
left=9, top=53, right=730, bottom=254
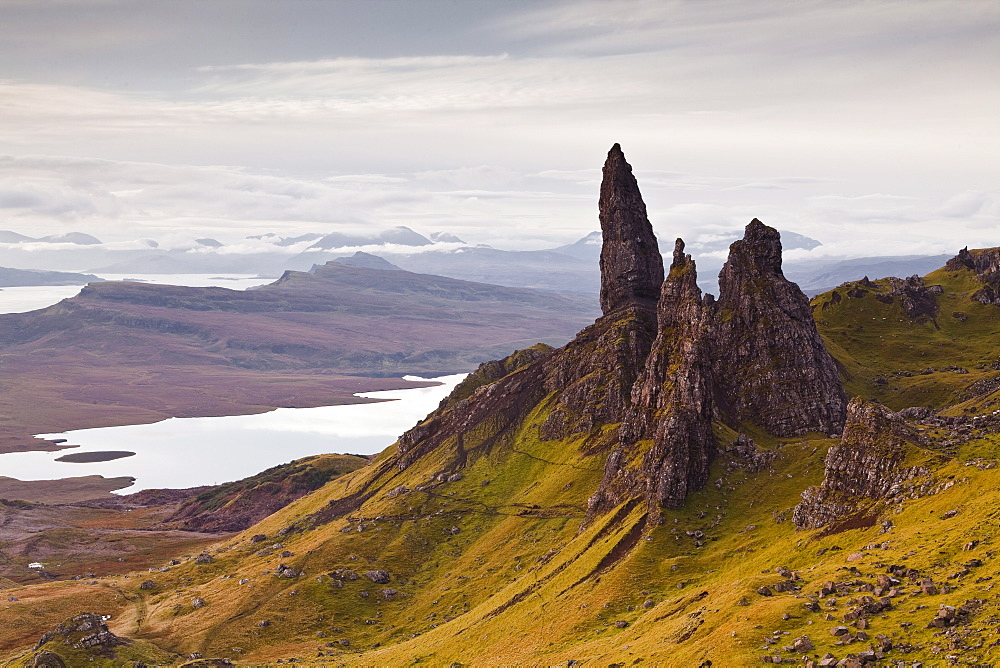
left=0, top=374, right=466, bottom=494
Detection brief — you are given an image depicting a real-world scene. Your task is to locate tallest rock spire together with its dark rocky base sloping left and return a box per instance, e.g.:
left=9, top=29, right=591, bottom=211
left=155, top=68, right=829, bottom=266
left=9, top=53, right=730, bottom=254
left=399, top=144, right=663, bottom=467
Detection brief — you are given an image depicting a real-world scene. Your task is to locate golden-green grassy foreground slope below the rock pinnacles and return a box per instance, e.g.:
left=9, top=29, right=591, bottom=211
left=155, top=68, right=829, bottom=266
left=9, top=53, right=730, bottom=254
left=0, top=415, right=1000, bottom=666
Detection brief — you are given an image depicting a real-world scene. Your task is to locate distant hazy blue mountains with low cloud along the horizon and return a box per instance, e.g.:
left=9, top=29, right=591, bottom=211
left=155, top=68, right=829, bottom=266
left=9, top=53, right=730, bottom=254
left=0, top=227, right=984, bottom=295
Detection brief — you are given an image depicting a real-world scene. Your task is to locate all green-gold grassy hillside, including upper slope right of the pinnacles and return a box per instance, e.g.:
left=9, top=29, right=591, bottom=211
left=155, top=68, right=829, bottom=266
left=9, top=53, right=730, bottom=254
left=0, top=254, right=1000, bottom=666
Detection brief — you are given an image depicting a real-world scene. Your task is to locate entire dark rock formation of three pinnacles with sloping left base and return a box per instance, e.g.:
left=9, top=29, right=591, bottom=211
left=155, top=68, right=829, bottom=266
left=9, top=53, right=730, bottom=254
left=394, top=150, right=845, bottom=518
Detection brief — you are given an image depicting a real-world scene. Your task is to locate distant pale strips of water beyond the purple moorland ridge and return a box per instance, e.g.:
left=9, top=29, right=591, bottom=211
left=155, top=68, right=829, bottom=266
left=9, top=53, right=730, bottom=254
left=0, top=274, right=277, bottom=313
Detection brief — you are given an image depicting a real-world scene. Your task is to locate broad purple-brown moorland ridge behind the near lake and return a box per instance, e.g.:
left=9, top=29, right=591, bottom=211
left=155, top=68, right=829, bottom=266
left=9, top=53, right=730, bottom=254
left=0, top=262, right=596, bottom=460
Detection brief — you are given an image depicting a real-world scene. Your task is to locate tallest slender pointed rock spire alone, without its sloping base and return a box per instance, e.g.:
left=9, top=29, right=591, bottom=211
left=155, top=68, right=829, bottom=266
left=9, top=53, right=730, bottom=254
left=599, top=144, right=663, bottom=315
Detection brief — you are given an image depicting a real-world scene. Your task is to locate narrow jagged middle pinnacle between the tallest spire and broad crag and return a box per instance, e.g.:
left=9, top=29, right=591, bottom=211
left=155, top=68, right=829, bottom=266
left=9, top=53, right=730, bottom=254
left=589, top=239, right=715, bottom=512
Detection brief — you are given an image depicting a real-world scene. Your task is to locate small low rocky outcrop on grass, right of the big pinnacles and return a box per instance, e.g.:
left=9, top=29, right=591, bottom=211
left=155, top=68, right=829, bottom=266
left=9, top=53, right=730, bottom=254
left=792, top=398, right=929, bottom=529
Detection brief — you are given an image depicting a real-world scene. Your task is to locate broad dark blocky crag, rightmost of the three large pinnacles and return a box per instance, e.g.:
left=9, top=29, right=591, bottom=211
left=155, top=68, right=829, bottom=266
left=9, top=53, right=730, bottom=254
left=713, top=218, right=847, bottom=436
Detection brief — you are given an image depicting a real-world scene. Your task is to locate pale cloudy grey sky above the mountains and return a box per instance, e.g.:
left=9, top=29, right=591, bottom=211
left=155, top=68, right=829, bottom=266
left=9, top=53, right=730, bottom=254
left=0, top=0, right=1000, bottom=256
